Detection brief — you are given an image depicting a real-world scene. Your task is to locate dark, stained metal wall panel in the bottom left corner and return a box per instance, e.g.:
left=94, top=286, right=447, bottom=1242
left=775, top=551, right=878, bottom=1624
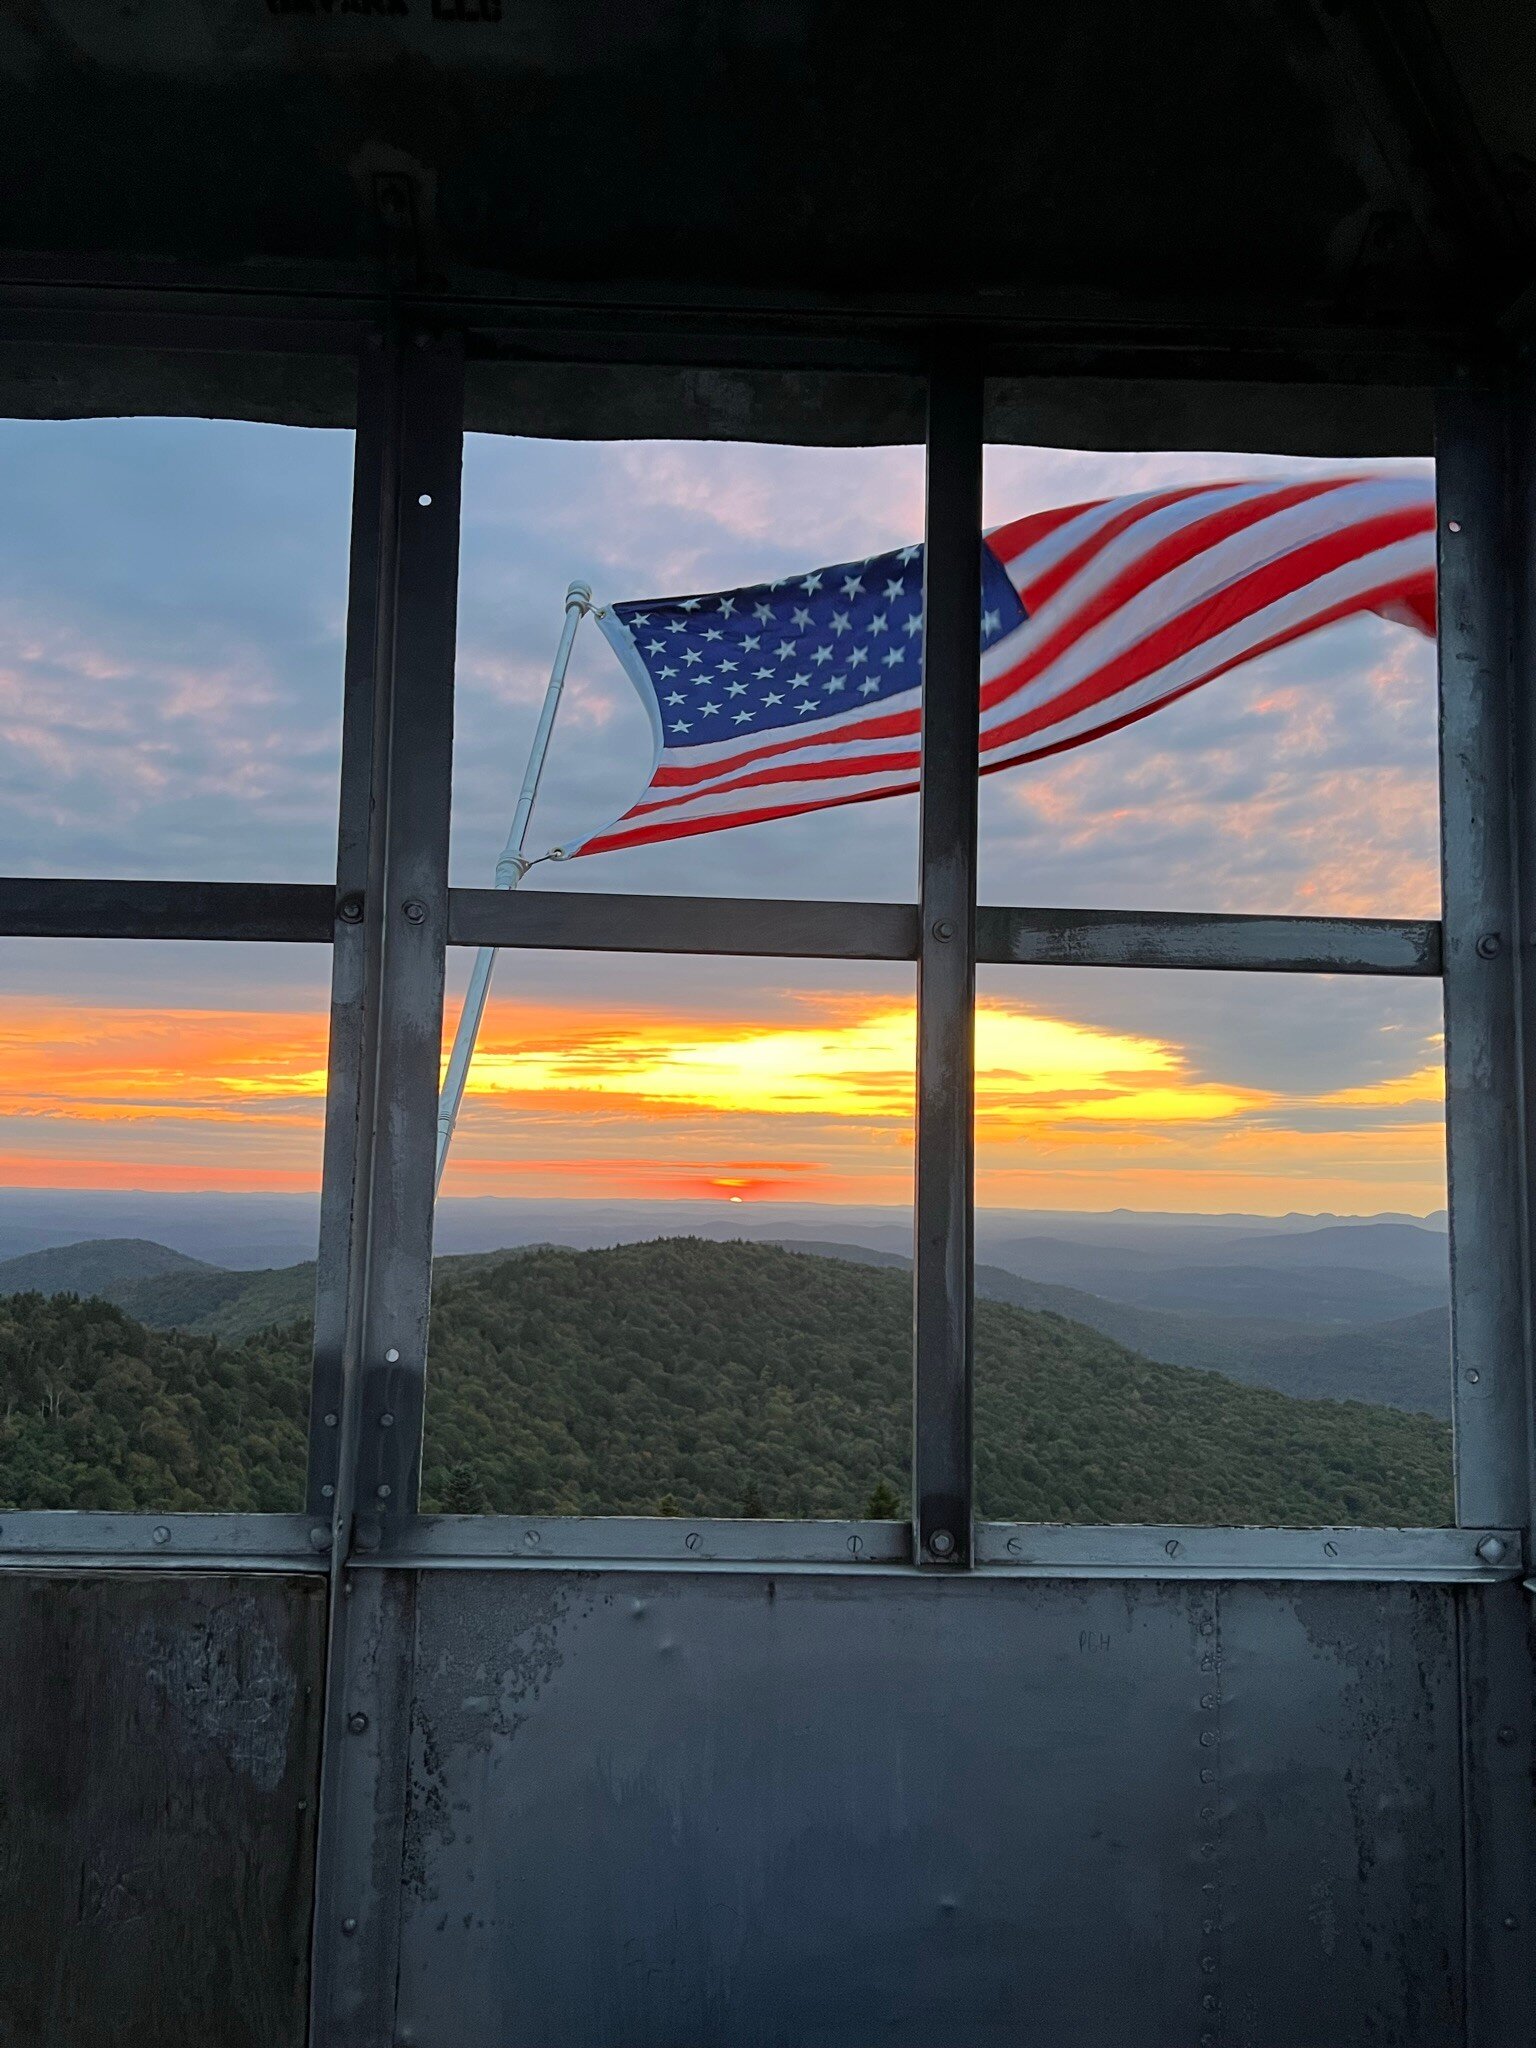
left=0, top=1571, right=326, bottom=2048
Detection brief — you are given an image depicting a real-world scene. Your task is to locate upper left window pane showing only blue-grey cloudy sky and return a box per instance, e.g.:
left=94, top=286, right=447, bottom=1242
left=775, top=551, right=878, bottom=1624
left=0, top=420, right=352, bottom=881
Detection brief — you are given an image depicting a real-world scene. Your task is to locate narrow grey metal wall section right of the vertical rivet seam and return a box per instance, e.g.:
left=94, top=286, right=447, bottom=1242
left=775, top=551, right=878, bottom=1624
left=1202, top=1585, right=1464, bottom=2048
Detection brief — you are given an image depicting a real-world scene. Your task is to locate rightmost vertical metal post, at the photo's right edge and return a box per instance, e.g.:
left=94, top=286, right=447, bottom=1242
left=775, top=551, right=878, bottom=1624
left=1436, top=389, right=1530, bottom=1526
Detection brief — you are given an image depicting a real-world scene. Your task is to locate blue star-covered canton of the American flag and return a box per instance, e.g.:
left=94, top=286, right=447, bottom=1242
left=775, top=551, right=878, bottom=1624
left=614, top=545, right=1024, bottom=748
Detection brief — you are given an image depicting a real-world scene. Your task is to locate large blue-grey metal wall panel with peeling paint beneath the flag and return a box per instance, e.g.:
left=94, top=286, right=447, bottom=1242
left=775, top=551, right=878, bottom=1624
left=397, top=1571, right=1462, bottom=2048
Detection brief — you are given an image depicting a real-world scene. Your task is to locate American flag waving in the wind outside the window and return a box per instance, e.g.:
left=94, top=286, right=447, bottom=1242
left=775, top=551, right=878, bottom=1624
left=561, top=475, right=1436, bottom=856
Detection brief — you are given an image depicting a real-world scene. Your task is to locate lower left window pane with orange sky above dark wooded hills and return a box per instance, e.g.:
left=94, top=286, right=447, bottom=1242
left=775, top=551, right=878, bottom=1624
left=0, top=940, right=330, bottom=1511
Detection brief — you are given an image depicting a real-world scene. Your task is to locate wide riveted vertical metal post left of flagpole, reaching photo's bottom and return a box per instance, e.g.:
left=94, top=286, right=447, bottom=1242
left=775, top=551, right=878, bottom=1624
left=309, top=334, right=463, bottom=2048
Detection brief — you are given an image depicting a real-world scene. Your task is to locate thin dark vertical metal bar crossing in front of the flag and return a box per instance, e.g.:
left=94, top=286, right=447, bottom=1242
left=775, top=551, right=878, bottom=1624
left=911, top=367, right=983, bottom=1567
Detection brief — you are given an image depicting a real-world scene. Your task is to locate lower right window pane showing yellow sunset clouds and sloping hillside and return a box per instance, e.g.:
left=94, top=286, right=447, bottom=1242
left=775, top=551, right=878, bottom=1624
left=977, top=969, right=1452, bottom=1526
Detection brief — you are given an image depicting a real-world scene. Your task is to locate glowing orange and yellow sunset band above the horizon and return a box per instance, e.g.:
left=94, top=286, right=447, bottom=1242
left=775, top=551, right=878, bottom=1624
left=0, top=995, right=1444, bottom=1210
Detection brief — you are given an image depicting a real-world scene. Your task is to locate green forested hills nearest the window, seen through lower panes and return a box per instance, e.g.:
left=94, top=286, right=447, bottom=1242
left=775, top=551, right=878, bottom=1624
left=0, top=1239, right=1450, bottom=1524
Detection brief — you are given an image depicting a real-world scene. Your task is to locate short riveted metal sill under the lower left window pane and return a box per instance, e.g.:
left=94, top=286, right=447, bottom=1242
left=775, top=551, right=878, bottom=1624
left=0, top=1507, right=330, bottom=1571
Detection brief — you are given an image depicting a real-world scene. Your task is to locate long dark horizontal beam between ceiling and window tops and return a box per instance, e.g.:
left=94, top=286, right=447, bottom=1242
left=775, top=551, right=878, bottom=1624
left=0, top=260, right=1475, bottom=383
